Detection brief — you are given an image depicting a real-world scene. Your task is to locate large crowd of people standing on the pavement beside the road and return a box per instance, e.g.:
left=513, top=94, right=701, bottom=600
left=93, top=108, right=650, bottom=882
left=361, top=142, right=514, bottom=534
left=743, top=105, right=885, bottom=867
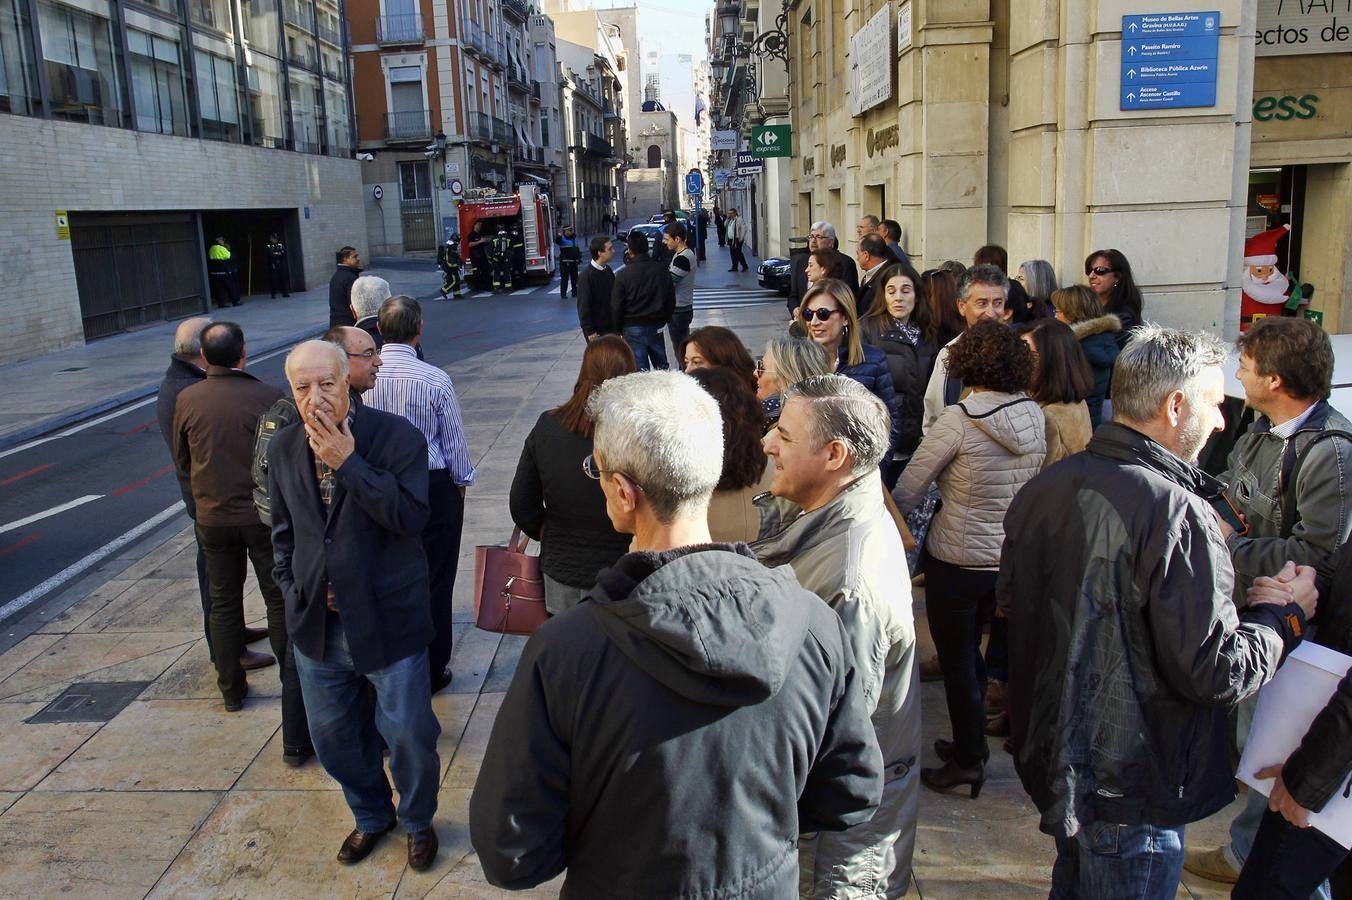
left=150, top=216, right=1352, bottom=897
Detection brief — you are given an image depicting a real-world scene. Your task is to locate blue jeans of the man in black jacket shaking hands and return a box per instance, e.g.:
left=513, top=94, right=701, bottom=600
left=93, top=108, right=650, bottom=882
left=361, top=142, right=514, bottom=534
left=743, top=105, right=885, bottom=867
left=1046, top=822, right=1183, bottom=900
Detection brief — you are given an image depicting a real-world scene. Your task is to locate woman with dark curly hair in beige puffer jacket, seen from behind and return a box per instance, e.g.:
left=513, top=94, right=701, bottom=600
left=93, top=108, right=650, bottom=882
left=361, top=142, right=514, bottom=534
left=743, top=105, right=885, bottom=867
left=892, top=320, right=1046, bottom=800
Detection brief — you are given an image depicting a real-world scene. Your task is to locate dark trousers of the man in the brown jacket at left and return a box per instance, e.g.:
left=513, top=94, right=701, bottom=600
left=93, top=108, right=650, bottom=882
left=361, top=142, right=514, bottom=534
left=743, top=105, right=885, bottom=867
left=197, top=522, right=287, bottom=700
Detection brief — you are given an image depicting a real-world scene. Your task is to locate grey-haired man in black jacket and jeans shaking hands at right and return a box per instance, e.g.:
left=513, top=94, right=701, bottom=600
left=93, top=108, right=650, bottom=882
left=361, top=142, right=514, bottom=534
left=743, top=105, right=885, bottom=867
left=996, top=326, right=1314, bottom=899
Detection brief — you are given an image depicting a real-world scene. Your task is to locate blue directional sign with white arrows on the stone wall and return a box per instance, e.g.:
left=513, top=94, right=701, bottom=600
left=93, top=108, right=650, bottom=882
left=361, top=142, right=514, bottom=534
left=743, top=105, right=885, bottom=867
left=1118, top=12, right=1221, bottom=109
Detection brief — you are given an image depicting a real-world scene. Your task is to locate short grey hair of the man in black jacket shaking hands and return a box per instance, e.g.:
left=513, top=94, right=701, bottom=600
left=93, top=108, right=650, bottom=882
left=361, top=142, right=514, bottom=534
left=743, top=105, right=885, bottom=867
left=1113, top=323, right=1229, bottom=423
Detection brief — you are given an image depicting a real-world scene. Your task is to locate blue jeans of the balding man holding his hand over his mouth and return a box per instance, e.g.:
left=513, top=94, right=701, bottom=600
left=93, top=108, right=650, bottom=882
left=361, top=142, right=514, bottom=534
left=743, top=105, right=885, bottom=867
left=293, top=615, right=441, bottom=832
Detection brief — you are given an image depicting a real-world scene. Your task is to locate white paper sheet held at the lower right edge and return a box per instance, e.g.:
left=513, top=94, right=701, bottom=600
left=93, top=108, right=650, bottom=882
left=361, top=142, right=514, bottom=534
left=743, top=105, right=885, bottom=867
left=1237, top=641, right=1352, bottom=850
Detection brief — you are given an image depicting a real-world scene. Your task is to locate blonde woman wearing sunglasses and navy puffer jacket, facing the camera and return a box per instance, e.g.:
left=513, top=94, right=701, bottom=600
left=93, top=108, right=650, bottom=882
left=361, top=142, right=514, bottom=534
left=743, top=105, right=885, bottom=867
left=798, top=278, right=902, bottom=485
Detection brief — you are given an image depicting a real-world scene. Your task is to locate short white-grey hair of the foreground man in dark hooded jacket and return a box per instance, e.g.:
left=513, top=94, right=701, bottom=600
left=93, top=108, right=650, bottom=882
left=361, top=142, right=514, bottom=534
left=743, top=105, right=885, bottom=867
left=587, top=372, right=723, bottom=523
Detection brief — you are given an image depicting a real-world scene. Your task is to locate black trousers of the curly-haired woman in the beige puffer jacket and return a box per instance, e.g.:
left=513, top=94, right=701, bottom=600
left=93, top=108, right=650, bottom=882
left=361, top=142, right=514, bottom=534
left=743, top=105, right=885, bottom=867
left=925, top=555, right=996, bottom=766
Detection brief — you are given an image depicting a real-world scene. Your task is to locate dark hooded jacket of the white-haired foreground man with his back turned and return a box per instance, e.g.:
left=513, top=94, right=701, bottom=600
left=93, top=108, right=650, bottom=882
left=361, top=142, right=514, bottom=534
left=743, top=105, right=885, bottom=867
left=469, top=545, right=883, bottom=900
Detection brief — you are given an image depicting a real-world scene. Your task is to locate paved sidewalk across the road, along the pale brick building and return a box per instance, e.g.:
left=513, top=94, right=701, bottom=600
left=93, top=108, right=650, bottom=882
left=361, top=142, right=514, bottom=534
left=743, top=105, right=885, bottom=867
left=0, top=258, right=435, bottom=450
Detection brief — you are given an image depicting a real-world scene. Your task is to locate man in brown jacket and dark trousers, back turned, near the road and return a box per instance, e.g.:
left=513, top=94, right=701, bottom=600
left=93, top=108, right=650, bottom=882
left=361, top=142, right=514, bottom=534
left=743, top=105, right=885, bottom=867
left=173, top=322, right=287, bottom=712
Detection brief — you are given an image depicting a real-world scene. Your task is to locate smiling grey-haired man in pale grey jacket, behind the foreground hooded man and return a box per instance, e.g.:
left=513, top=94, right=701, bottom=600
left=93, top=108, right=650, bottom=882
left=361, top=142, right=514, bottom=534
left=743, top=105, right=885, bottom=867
left=752, top=374, right=921, bottom=899
